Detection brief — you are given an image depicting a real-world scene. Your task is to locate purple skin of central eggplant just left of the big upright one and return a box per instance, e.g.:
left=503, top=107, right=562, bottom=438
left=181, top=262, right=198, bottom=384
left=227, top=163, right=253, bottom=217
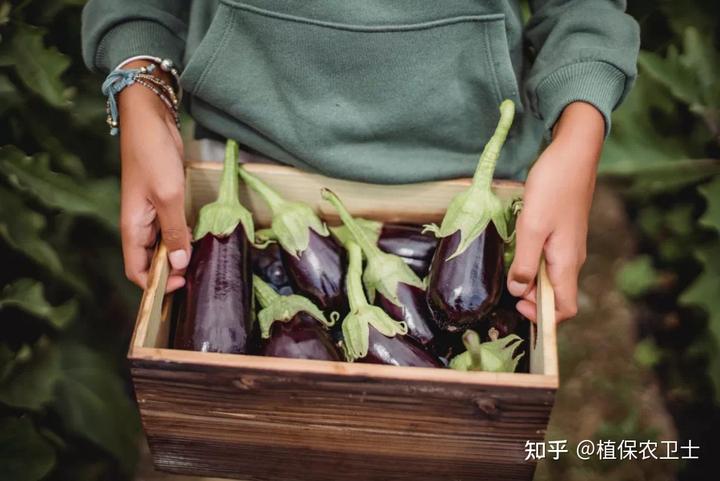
left=375, top=282, right=438, bottom=347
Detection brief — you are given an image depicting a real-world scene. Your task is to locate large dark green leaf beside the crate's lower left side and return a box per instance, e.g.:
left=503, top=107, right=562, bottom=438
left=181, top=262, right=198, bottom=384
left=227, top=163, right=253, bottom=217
left=54, top=343, right=139, bottom=472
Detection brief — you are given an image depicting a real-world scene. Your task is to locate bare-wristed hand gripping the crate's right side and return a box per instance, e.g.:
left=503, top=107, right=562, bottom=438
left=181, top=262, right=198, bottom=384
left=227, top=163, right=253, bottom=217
left=508, top=102, right=605, bottom=322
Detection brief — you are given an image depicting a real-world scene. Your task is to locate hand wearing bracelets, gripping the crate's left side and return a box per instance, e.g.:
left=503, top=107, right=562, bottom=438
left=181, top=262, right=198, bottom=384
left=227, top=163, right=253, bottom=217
left=118, top=61, right=190, bottom=292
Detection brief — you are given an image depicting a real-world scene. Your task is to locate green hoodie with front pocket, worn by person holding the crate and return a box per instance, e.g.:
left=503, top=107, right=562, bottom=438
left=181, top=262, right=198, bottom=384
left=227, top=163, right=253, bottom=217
left=83, top=0, right=639, bottom=183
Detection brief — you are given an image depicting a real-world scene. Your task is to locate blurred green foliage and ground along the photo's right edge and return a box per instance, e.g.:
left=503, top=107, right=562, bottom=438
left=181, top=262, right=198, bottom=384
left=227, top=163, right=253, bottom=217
left=601, top=0, right=720, bottom=479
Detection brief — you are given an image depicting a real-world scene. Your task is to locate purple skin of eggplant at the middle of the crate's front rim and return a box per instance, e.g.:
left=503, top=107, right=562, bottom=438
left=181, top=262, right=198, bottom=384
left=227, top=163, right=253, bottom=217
left=357, top=326, right=443, bottom=367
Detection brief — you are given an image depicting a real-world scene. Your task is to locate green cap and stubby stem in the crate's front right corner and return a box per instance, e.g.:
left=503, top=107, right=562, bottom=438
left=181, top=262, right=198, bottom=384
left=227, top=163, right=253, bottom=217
left=450, top=329, right=525, bottom=372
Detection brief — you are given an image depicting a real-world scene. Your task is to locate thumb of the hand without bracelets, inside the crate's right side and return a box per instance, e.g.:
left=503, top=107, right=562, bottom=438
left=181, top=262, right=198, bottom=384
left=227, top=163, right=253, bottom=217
left=507, top=214, right=547, bottom=297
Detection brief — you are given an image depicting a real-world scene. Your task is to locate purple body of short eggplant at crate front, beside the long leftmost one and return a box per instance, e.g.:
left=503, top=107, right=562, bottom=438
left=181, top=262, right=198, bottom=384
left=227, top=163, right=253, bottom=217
left=259, top=312, right=342, bottom=361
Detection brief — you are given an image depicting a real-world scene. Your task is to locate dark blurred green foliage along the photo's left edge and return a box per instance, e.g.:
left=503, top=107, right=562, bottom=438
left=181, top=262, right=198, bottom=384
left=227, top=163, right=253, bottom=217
left=0, top=0, right=139, bottom=481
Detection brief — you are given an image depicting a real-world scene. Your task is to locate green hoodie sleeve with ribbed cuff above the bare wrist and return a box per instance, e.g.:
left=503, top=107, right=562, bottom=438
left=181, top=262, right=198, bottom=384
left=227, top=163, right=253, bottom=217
left=525, top=0, right=640, bottom=134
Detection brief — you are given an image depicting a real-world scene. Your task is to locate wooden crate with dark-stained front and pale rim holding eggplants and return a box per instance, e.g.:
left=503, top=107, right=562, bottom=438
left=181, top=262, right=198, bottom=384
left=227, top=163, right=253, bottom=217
left=128, top=163, right=558, bottom=481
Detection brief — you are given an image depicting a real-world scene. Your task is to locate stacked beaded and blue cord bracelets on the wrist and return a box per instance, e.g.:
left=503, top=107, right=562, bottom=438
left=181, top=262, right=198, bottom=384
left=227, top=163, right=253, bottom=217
left=102, top=58, right=180, bottom=135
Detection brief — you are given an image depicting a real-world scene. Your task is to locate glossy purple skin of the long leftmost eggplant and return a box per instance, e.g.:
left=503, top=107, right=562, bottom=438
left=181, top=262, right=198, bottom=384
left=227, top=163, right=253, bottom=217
left=174, top=224, right=252, bottom=354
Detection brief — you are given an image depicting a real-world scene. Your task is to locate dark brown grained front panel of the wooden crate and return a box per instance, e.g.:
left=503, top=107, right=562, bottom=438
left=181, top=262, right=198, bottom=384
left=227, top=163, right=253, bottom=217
left=132, top=360, right=554, bottom=481
